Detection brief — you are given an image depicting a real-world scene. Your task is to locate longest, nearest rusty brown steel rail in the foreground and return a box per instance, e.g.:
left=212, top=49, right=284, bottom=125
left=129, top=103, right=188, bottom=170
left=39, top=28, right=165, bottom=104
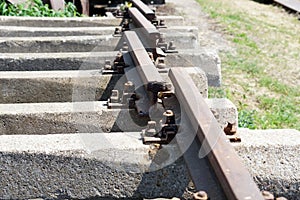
left=169, top=68, right=264, bottom=200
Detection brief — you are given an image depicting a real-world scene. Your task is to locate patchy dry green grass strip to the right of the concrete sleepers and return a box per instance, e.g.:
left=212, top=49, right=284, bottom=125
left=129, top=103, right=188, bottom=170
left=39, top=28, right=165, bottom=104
left=198, top=0, right=300, bottom=130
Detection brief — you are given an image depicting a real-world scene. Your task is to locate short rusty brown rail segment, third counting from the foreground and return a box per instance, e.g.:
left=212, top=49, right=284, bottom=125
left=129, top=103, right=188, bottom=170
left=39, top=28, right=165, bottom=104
left=128, top=8, right=160, bottom=42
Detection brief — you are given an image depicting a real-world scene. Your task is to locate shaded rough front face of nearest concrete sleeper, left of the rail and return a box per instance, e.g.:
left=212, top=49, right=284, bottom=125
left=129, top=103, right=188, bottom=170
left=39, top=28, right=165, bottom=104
left=0, top=152, right=189, bottom=200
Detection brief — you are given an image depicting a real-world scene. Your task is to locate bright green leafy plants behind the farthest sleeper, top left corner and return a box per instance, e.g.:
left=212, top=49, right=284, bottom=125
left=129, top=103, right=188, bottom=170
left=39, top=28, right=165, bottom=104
left=0, top=0, right=80, bottom=17
